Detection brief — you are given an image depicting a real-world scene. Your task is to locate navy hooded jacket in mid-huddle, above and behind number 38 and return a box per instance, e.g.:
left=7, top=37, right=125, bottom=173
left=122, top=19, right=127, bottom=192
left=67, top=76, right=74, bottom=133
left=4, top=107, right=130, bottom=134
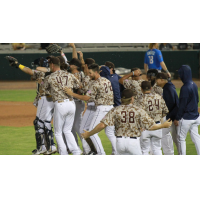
left=100, top=66, right=124, bottom=107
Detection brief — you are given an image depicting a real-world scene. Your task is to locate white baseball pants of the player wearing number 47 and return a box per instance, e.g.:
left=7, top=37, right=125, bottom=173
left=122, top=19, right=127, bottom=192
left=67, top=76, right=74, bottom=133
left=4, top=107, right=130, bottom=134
left=54, top=99, right=81, bottom=155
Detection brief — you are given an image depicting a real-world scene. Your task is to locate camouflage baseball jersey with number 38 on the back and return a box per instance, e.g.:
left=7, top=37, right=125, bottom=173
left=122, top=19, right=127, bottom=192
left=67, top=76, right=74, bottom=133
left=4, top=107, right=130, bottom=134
left=101, top=104, right=155, bottom=137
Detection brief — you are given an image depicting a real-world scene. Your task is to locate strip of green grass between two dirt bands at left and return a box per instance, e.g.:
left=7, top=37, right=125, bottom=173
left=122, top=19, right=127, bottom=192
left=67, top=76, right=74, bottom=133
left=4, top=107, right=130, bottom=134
left=0, top=90, right=36, bottom=102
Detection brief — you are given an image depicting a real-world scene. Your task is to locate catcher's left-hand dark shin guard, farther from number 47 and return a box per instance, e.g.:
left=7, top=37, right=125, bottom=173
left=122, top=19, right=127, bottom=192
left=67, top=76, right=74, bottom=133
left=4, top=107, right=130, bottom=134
left=33, top=117, right=44, bottom=150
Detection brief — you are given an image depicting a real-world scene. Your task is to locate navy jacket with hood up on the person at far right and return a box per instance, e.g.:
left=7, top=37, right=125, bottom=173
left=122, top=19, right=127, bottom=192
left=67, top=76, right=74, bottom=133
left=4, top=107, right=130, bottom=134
left=176, top=65, right=199, bottom=120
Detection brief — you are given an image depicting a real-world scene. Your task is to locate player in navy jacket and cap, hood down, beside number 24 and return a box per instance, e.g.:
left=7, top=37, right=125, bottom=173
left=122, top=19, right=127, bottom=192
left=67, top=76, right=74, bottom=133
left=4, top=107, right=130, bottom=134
left=156, top=73, right=179, bottom=155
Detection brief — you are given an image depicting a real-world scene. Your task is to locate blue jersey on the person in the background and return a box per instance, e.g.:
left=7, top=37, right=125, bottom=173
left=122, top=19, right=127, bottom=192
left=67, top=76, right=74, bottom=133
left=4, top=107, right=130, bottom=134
left=144, top=49, right=163, bottom=70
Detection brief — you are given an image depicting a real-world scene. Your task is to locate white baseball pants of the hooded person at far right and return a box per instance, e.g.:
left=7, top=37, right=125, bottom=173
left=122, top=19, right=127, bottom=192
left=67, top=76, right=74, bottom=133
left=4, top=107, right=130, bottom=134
left=177, top=117, right=200, bottom=155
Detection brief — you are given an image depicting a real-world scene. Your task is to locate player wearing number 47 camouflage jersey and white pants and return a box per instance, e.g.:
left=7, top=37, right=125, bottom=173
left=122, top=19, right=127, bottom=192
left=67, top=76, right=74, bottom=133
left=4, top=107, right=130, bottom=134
left=44, top=56, right=81, bottom=155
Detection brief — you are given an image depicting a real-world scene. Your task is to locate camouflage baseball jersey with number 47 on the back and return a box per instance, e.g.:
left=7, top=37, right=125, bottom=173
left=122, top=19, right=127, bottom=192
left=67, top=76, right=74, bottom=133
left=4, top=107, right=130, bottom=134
left=44, top=70, right=81, bottom=102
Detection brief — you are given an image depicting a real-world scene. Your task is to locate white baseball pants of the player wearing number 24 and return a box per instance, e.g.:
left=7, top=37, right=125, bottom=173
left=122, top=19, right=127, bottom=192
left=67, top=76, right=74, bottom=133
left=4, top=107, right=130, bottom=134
left=140, top=125, right=162, bottom=155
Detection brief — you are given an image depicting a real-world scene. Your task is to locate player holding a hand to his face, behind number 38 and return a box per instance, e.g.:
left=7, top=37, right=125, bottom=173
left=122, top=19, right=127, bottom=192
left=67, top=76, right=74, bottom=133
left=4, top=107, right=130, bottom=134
left=119, top=68, right=144, bottom=99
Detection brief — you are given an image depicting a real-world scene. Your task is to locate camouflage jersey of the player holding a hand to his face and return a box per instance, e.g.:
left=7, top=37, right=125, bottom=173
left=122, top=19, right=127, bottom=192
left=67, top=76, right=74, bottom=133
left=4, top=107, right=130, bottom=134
left=123, top=79, right=144, bottom=99
